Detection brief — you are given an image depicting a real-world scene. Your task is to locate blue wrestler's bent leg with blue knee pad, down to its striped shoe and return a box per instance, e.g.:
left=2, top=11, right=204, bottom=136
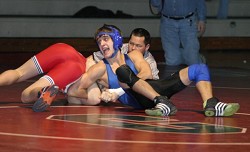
left=180, top=64, right=240, bottom=116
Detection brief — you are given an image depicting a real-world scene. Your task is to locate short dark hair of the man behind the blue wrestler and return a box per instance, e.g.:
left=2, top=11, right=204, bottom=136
left=129, top=28, right=151, bottom=45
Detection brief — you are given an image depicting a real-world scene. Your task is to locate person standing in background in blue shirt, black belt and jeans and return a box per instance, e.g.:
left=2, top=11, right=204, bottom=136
left=150, top=0, right=206, bottom=66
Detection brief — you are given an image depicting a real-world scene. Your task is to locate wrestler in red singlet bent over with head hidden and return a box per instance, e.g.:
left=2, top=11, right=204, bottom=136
left=0, top=43, right=100, bottom=112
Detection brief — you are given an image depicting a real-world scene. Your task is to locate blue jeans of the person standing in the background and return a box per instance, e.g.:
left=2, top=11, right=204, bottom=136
left=160, top=15, right=202, bottom=65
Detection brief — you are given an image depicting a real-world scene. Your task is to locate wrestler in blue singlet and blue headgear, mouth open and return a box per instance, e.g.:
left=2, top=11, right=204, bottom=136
left=68, top=25, right=239, bottom=116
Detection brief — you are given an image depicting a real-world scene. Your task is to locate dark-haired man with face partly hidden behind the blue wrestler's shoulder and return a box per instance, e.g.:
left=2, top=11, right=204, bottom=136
left=93, top=28, right=159, bottom=80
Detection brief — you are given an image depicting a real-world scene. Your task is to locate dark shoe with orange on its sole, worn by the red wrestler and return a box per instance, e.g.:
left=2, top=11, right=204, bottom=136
left=32, top=85, right=59, bottom=112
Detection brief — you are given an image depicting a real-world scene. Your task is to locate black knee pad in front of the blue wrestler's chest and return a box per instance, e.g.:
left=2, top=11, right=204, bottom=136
left=116, top=64, right=139, bottom=88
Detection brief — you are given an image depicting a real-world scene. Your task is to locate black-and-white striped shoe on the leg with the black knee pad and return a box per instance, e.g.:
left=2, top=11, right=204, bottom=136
left=145, top=96, right=177, bottom=116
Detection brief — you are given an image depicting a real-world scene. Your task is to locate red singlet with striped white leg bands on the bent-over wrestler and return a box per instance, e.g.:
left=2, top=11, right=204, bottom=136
left=32, top=43, right=86, bottom=90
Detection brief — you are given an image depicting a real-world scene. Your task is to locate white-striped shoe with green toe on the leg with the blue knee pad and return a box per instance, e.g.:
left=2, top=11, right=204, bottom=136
left=204, top=97, right=240, bottom=117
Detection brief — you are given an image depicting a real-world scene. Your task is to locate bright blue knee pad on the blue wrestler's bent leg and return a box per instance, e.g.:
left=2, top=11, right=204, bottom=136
left=188, top=64, right=210, bottom=83
